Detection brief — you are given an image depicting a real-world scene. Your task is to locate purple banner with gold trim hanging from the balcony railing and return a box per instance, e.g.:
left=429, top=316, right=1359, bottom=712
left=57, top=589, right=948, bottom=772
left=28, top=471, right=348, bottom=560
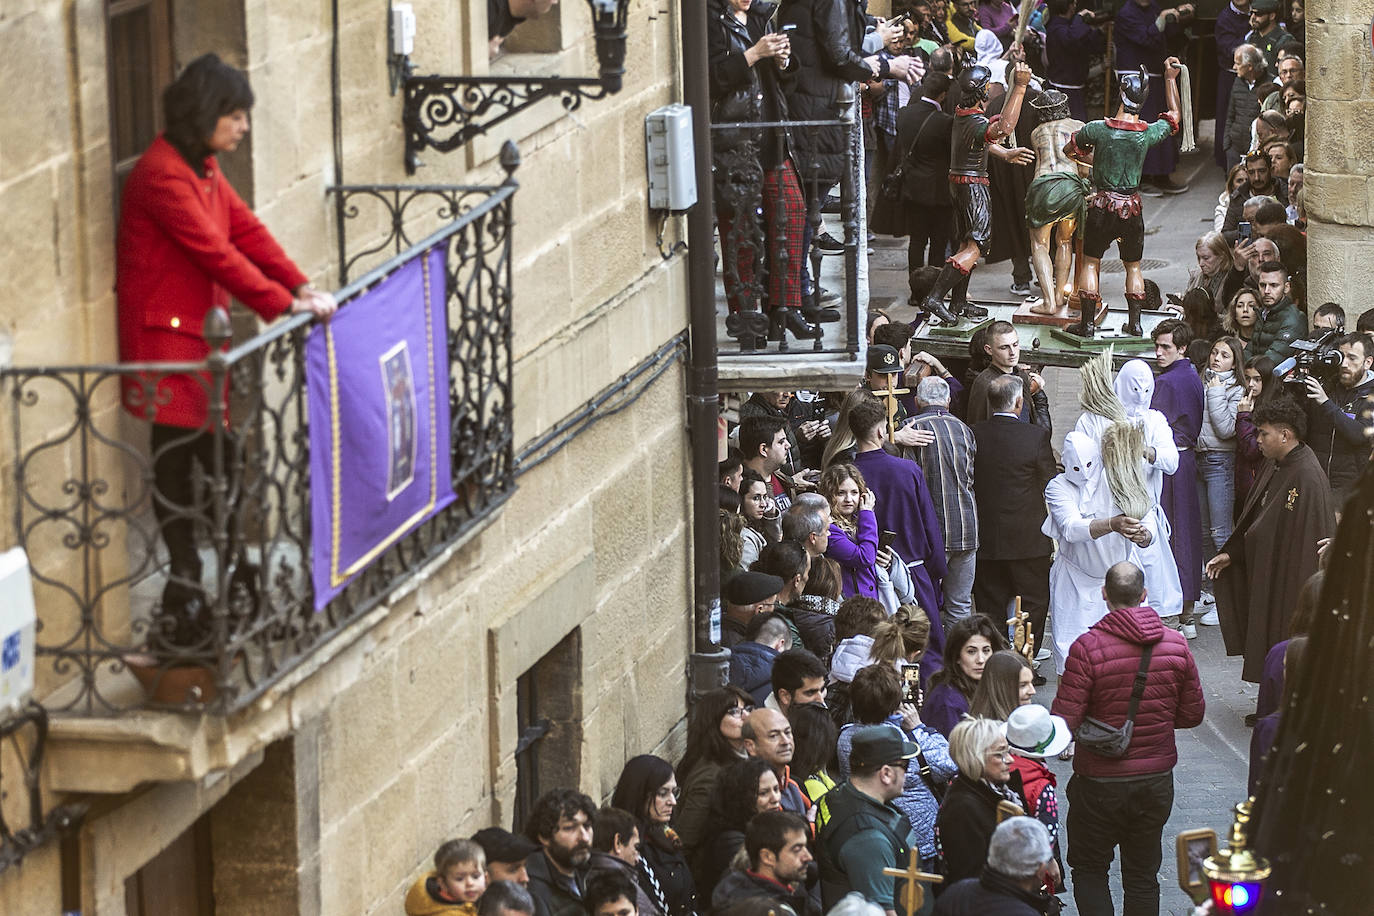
left=305, top=247, right=453, bottom=611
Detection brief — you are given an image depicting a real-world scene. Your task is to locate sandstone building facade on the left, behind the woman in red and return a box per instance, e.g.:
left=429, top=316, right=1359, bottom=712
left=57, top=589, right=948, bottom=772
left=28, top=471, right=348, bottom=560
left=0, top=0, right=691, bottom=916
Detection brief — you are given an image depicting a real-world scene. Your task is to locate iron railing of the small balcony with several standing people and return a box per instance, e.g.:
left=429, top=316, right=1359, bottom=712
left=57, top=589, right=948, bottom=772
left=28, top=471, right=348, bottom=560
left=710, top=102, right=867, bottom=358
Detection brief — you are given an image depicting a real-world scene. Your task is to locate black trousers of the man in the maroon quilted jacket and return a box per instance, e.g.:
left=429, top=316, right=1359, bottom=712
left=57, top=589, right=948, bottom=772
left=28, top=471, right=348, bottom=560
left=1068, top=773, right=1173, bottom=916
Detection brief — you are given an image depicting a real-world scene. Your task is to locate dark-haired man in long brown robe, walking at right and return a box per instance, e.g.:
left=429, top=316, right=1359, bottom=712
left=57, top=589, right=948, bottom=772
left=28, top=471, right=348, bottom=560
left=1206, top=397, right=1336, bottom=683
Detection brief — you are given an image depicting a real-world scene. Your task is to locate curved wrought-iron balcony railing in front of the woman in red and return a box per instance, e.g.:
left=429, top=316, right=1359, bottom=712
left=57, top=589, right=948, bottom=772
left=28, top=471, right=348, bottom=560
left=0, top=180, right=517, bottom=715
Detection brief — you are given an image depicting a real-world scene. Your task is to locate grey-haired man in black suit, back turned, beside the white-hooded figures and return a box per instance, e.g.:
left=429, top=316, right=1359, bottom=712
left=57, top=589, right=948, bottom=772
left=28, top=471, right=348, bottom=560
left=973, top=375, right=1059, bottom=667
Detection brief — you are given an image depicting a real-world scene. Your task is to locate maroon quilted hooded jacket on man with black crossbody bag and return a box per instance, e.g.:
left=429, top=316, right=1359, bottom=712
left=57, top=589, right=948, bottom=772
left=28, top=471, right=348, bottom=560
left=1051, top=607, right=1206, bottom=779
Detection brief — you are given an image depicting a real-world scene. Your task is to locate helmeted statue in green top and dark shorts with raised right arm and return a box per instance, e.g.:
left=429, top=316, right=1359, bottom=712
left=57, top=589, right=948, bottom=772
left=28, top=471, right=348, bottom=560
left=1063, top=58, right=1180, bottom=338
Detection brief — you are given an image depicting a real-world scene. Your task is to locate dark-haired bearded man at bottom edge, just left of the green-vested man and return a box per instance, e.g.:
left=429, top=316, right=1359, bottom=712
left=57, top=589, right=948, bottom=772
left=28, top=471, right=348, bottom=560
left=710, top=812, right=820, bottom=916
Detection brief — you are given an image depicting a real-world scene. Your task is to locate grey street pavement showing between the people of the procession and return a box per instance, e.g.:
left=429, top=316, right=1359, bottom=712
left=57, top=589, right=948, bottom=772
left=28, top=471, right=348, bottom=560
left=870, top=140, right=1257, bottom=916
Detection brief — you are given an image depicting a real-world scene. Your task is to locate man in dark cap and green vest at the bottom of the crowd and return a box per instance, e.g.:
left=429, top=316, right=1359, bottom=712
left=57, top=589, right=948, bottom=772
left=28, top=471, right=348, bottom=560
left=816, top=725, right=918, bottom=916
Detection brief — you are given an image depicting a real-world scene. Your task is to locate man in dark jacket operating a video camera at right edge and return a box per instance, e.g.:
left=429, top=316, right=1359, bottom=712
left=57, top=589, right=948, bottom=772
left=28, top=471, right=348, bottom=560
left=1307, top=334, right=1374, bottom=505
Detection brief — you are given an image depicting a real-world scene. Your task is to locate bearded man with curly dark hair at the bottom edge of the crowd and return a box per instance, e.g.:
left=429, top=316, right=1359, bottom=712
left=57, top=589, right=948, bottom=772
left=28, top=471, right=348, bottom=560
left=525, top=788, right=596, bottom=916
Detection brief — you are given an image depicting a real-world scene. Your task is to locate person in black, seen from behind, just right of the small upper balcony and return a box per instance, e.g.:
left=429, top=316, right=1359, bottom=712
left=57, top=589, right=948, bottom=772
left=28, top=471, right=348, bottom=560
left=897, top=71, right=954, bottom=305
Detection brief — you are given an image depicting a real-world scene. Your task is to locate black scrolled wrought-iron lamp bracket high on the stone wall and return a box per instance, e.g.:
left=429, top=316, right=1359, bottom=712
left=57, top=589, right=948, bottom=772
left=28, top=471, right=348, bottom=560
left=401, top=0, right=629, bottom=174
